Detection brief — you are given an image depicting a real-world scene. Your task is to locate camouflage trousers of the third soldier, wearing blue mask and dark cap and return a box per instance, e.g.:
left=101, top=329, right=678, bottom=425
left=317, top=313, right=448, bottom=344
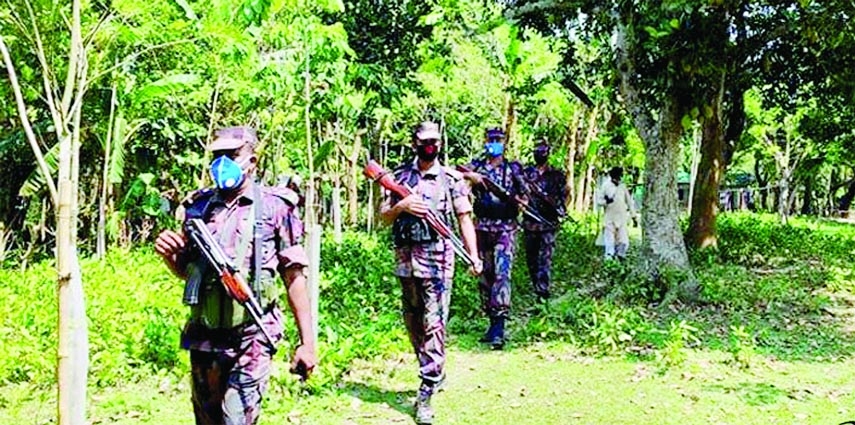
left=476, top=229, right=517, bottom=317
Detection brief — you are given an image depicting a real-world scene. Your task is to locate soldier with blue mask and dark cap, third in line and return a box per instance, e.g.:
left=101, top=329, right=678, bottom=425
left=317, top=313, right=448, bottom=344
left=464, top=128, right=528, bottom=349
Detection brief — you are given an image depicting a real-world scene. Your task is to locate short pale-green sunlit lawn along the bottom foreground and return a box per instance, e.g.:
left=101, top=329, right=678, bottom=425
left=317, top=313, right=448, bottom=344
left=0, top=344, right=855, bottom=425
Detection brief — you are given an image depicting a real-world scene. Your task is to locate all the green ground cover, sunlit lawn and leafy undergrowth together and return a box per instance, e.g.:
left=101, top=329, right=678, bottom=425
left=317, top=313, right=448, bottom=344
left=0, top=211, right=855, bottom=425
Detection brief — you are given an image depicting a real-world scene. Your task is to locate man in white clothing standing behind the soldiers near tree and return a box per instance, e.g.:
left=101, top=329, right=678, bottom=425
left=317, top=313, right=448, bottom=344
left=597, top=167, right=637, bottom=260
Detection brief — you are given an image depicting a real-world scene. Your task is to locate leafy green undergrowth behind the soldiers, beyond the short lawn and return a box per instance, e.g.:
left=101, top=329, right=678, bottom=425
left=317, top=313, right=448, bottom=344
left=0, top=215, right=855, bottom=388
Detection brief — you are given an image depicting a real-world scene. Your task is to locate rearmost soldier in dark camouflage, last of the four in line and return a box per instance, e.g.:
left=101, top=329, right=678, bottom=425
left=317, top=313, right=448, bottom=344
left=523, top=143, right=567, bottom=301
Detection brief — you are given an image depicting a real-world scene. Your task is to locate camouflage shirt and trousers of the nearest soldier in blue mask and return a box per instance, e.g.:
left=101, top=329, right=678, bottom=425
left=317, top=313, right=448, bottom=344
left=181, top=183, right=308, bottom=425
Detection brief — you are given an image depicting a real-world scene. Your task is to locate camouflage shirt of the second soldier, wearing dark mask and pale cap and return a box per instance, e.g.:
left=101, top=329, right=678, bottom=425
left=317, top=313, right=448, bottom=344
left=381, top=161, right=472, bottom=278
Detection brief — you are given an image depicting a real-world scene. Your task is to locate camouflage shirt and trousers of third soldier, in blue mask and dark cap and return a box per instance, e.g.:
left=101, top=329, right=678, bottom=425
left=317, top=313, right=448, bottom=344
left=468, top=160, right=528, bottom=317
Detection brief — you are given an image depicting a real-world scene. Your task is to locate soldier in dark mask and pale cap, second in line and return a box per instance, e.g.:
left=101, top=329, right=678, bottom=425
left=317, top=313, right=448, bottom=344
left=380, top=122, right=481, bottom=424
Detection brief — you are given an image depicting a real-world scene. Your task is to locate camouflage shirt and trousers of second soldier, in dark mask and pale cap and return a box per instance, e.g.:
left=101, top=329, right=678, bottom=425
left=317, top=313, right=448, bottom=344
left=381, top=162, right=472, bottom=389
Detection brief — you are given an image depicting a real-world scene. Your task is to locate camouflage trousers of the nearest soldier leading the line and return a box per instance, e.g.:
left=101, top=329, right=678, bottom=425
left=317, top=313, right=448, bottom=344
left=190, top=338, right=272, bottom=425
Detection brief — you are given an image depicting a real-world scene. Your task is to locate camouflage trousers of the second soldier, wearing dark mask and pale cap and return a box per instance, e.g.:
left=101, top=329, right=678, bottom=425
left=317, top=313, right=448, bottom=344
left=399, top=277, right=451, bottom=386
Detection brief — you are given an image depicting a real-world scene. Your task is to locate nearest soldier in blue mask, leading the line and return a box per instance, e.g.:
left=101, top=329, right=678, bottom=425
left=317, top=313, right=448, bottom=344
left=155, top=127, right=317, bottom=425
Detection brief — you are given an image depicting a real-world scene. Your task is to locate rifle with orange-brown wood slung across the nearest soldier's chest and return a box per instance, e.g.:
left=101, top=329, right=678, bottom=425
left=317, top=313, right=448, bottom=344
left=187, top=218, right=276, bottom=352
